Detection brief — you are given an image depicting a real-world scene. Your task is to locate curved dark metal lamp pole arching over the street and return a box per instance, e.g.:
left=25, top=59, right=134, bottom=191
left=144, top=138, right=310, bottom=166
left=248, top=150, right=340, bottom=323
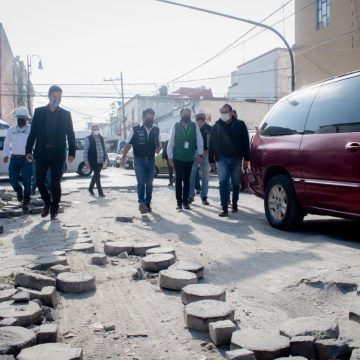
left=156, top=0, right=295, bottom=91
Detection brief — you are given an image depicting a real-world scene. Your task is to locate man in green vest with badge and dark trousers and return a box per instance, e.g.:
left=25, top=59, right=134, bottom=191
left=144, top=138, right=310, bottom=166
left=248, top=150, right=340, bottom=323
left=167, top=108, right=204, bottom=211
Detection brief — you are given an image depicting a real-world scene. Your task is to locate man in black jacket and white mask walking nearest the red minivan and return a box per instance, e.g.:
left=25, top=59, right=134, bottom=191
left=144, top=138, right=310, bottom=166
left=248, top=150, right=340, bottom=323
left=209, top=104, right=250, bottom=217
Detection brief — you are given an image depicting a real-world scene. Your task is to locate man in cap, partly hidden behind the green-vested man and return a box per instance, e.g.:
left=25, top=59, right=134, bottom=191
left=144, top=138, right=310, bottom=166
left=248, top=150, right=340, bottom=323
left=189, top=110, right=212, bottom=205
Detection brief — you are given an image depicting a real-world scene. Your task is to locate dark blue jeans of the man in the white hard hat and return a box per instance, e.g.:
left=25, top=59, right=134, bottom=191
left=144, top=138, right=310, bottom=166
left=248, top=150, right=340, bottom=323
left=9, top=156, right=32, bottom=200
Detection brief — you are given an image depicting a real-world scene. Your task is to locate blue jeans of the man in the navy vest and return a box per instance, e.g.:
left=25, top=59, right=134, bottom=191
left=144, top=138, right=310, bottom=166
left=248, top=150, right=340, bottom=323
left=134, top=157, right=155, bottom=205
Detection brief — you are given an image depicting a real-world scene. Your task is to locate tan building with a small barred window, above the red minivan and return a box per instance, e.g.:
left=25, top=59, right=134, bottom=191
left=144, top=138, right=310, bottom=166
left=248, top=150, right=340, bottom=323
left=295, top=0, right=360, bottom=88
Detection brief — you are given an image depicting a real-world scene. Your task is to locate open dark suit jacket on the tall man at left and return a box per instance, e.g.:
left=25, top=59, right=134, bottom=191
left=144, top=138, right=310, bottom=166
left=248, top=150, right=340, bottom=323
left=26, top=106, right=76, bottom=162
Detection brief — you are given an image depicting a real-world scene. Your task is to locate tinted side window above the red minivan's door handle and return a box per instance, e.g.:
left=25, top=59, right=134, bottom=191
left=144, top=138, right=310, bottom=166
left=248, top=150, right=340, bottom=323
left=305, top=76, right=360, bottom=134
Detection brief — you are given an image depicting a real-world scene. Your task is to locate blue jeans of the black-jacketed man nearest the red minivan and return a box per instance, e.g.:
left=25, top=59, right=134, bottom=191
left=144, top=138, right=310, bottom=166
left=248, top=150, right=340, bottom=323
left=216, top=156, right=241, bottom=209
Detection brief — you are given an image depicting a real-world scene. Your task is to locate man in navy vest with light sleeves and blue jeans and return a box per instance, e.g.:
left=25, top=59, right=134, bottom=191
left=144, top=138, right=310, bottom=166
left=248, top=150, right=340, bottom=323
left=121, top=108, right=160, bottom=214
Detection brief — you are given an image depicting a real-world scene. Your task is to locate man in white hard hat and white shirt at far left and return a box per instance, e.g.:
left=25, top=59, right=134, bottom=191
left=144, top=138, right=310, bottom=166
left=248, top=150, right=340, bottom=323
left=3, top=106, right=32, bottom=212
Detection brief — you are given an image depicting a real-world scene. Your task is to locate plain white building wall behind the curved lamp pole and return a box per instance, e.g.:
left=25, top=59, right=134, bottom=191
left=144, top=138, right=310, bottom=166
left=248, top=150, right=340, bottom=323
left=228, top=48, right=291, bottom=104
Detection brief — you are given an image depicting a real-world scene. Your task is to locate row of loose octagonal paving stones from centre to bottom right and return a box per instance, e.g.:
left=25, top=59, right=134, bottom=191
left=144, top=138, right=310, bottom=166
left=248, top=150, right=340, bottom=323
left=104, top=241, right=360, bottom=360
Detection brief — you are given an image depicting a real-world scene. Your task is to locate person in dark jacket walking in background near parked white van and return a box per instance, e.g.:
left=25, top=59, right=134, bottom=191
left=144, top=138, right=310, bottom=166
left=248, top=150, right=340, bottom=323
left=84, top=125, right=108, bottom=197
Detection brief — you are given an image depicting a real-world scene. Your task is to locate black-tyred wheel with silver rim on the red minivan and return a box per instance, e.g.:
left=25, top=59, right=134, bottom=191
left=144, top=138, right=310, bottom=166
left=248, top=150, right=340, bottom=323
left=264, top=175, right=304, bottom=230
